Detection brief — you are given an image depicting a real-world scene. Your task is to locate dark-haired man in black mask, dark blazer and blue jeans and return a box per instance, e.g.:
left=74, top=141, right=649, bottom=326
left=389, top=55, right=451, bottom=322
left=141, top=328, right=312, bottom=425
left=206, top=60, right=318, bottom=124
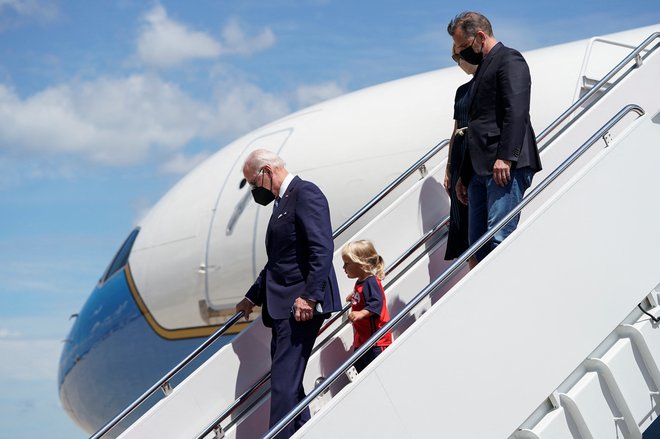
left=447, top=12, right=541, bottom=261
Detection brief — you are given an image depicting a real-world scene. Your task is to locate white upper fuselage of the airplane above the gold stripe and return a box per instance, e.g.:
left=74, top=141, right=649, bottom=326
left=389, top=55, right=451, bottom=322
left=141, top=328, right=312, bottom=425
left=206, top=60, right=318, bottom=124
left=129, top=28, right=651, bottom=338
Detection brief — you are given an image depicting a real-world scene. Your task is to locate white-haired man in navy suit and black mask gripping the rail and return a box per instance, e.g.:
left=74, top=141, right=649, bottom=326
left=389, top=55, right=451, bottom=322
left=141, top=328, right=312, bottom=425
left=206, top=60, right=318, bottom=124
left=236, top=149, right=342, bottom=439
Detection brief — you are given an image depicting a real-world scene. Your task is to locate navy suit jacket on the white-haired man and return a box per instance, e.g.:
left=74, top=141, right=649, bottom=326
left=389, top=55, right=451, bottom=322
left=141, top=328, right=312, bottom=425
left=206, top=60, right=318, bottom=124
left=246, top=177, right=341, bottom=326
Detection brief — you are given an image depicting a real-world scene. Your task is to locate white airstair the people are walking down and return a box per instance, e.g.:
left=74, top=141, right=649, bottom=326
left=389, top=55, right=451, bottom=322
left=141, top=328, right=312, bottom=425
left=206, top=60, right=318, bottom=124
left=93, top=33, right=660, bottom=439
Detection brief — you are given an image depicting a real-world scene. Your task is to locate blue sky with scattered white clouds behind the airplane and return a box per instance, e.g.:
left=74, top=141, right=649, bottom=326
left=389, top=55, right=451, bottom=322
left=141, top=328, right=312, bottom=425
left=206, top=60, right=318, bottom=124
left=0, top=0, right=660, bottom=439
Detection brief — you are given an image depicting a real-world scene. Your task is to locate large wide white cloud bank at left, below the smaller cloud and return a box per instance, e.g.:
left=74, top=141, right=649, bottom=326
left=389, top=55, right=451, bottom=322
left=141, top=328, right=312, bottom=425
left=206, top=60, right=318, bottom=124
left=0, top=75, right=294, bottom=169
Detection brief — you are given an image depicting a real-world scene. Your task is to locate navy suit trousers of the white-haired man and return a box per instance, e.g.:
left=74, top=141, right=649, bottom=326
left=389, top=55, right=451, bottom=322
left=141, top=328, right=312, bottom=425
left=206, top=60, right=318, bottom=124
left=270, top=315, right=325, bottom=439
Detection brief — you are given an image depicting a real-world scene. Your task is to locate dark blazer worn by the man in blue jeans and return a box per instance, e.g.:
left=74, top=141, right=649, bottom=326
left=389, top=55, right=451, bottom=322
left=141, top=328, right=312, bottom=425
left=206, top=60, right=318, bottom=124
left=463, top=43, right=541, bottom=181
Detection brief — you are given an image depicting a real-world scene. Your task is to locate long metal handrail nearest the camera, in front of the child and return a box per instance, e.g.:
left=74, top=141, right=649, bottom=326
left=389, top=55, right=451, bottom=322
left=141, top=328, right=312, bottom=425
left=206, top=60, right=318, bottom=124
left=262, top=104, right=644, bottom=439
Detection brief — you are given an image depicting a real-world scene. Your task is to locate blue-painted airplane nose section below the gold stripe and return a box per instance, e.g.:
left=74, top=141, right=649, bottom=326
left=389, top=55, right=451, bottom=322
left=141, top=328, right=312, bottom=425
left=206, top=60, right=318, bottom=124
left=58, top=229, right=227, bottom=434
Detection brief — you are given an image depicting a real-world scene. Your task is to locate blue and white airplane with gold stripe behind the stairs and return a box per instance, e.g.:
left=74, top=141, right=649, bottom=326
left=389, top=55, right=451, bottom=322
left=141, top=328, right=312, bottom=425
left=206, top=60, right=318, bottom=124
left=58, top=25, right=660, bottom=434
